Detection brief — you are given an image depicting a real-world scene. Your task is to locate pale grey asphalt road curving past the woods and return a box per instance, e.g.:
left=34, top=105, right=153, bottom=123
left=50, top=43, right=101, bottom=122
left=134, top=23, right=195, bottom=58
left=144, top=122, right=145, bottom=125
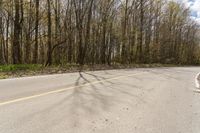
left=0, top=67, right=200, bottom=133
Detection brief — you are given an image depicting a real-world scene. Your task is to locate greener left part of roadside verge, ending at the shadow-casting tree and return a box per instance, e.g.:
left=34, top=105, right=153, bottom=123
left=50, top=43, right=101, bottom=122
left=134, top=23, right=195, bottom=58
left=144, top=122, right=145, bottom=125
left=0, top=64, right=79, bottom=79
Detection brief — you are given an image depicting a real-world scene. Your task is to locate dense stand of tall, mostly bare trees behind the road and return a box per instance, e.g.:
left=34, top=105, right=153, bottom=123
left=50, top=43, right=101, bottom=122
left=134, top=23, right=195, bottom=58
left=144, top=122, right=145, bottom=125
left=0, top=0, right=200, bottom=66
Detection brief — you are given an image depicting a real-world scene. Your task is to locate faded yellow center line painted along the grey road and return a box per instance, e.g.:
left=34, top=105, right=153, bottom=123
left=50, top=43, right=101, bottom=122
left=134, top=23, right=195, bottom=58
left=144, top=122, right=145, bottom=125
left=0, top=72, right=145, bottom=106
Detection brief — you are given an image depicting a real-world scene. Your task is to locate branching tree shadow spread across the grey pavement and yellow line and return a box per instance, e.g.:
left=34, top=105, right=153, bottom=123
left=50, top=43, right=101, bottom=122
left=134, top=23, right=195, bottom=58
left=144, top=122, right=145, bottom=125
left=23, top=72, right=146, bottom=131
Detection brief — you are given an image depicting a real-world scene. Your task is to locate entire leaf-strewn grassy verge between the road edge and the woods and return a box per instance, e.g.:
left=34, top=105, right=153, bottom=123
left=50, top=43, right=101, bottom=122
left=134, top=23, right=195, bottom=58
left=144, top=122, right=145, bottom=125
left=0, top=64, right=177, bottom=79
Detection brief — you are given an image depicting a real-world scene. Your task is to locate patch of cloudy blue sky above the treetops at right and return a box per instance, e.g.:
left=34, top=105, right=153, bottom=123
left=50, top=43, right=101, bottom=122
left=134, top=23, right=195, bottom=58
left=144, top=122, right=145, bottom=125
left=176, top=0, right=200, bottom=24
